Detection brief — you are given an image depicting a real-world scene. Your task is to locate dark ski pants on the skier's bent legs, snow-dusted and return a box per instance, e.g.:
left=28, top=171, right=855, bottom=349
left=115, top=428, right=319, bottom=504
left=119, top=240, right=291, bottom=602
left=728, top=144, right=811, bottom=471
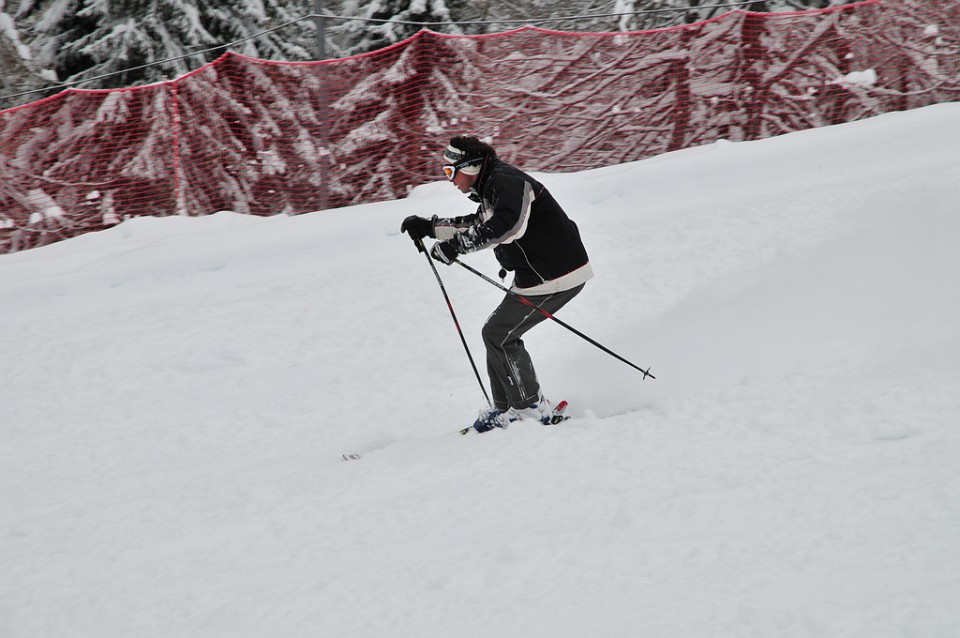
left=482, top=284, right=585, bottom=410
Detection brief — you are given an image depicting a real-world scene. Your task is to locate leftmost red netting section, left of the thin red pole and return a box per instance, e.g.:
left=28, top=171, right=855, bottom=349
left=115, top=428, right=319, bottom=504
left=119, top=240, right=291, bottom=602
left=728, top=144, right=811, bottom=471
left=0, top=85, right=182, bottom=250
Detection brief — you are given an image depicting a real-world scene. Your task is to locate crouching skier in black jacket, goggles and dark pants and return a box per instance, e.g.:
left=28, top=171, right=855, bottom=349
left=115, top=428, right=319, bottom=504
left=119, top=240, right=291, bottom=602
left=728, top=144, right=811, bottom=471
left=400, top=136, right=593, bottom=432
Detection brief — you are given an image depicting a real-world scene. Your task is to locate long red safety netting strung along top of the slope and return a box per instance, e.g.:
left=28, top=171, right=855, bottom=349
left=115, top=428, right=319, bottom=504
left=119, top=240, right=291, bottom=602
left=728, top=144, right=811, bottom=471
left=0, top=0, right=960, bottom=252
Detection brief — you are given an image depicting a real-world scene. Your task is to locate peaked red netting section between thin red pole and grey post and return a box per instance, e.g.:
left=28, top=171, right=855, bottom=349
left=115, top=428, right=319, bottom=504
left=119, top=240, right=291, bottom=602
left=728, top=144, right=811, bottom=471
left=172, top=54, right=330, bottom=215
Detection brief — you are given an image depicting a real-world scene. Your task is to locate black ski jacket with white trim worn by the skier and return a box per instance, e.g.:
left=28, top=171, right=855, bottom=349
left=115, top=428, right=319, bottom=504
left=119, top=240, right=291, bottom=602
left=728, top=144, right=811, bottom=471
left=434, top=158, right=593, bottom=294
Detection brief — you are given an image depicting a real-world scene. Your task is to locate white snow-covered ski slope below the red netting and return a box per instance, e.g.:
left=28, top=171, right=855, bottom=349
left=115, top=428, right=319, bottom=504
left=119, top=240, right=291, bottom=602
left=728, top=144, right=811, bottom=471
left=0, top=104, right=960, bottom=638
